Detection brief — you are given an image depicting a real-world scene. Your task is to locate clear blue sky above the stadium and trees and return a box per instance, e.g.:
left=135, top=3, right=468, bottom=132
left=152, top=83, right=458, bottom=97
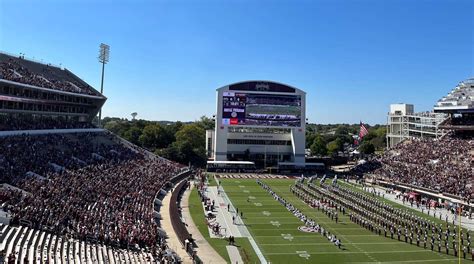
left=0, top=0, right=474, bottom=124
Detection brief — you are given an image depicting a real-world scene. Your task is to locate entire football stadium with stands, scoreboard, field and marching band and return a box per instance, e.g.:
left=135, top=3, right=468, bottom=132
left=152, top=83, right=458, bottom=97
left=0, top=45, right=474, bottom=263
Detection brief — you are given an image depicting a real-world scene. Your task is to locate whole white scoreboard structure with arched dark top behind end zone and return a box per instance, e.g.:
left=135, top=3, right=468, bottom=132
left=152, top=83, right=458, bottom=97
left=206, top=81, right=306, bottom=169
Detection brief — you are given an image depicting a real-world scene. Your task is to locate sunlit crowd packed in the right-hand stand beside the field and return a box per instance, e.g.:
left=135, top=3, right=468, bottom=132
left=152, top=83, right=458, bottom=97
left=372, top=136, right=474, bottom=201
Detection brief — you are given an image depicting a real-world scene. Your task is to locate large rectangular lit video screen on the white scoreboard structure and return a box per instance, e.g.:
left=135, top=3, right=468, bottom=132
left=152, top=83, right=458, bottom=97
left=222, top=92, right=301, bottom=127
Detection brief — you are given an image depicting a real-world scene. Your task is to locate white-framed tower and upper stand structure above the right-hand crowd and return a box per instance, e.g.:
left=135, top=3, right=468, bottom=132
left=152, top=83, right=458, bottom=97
left=387, top=78, right=474, bottom=148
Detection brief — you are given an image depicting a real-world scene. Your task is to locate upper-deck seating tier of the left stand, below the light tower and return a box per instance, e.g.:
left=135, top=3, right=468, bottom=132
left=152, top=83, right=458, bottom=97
left=0, top=53, right=99, bottom=95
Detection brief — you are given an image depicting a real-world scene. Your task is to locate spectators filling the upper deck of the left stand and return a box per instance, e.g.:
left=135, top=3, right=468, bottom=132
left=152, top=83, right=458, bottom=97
left=0, top=58, right=96, bottom=95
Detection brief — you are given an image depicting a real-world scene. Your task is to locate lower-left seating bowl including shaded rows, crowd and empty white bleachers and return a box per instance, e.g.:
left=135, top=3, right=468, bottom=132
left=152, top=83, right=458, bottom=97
left=0, top=132, right=187, bottom=263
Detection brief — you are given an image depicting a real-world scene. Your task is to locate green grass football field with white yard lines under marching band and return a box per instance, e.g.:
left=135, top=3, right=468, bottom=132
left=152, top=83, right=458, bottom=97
left=221, top=179, right=473, bottom=264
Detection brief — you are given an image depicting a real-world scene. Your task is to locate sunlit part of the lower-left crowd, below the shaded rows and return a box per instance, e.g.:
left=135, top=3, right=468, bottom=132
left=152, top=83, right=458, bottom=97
left=6, top=159, right=180, bottom=247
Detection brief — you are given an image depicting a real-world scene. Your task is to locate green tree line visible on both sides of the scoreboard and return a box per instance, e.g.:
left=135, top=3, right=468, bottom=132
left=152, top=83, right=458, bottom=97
left=102, top=116, right=386, bottom=167
